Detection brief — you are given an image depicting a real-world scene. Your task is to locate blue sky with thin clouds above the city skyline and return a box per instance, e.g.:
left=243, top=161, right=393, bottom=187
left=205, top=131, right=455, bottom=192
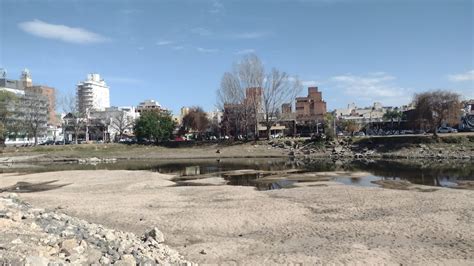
left=0, top=0, right=474, bottom=113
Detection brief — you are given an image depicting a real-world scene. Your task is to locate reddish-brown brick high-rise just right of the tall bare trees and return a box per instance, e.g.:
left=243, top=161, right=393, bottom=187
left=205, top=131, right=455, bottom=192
left=295, top=87, right=326, bottom=124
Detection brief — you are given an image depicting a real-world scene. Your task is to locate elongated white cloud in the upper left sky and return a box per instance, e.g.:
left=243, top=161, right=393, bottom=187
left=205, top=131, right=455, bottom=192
left=18, top=19, right=108, bottom=44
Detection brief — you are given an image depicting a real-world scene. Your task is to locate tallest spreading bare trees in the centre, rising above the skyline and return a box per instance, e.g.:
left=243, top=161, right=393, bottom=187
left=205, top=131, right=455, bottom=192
left=217, top=55, right=301, bottom=138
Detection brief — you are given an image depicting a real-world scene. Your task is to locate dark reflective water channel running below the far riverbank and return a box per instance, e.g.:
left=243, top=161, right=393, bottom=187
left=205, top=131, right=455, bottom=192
left=0, top=159, right=474, bottom=190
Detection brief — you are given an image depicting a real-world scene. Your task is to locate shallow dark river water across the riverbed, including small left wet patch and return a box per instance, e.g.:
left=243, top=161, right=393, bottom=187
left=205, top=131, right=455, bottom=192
left=0, top=158, right=474, bottom=193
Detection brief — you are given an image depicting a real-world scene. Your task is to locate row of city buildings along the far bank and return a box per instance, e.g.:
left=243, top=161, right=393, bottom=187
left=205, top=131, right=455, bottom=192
left=0, top=69, right=474, bottom=144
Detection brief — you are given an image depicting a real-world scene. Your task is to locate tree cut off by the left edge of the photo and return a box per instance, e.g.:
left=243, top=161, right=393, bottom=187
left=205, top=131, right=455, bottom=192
left=0, top=91, right=18, bottom=146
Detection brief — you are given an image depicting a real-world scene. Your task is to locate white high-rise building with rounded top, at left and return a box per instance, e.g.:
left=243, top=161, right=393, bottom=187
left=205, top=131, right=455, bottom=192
left=77, top=73, right=110, bottom=114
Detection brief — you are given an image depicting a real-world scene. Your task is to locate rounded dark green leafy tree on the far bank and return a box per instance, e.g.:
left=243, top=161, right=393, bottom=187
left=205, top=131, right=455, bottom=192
left=134, top=110, right=175, bottom=143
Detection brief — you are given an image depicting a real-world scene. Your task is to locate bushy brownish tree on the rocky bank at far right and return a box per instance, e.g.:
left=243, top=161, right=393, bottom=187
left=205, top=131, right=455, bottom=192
left=414, top=90, right=461, bottom=136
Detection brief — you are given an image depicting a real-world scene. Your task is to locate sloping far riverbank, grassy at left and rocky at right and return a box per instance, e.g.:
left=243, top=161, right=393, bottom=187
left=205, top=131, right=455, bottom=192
left=0, top=133, right=474, bottom=164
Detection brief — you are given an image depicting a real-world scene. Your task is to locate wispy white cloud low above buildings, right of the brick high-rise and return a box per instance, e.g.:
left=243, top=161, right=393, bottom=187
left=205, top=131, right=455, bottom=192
left=328, top=72, right=412, bottom=105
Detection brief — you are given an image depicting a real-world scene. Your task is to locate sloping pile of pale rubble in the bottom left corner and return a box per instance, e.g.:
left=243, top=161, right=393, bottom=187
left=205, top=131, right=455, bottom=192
left=0, top=194, right=192, bottom=265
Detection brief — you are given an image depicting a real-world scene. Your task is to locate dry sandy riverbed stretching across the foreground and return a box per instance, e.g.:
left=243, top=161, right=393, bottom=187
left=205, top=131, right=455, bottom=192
left=0, top=170, right=474, bottom=265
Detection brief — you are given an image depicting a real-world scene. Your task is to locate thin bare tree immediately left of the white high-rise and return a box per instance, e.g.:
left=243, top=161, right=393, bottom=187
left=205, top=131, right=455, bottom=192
left=58, top=93, right=84, bottom=144
